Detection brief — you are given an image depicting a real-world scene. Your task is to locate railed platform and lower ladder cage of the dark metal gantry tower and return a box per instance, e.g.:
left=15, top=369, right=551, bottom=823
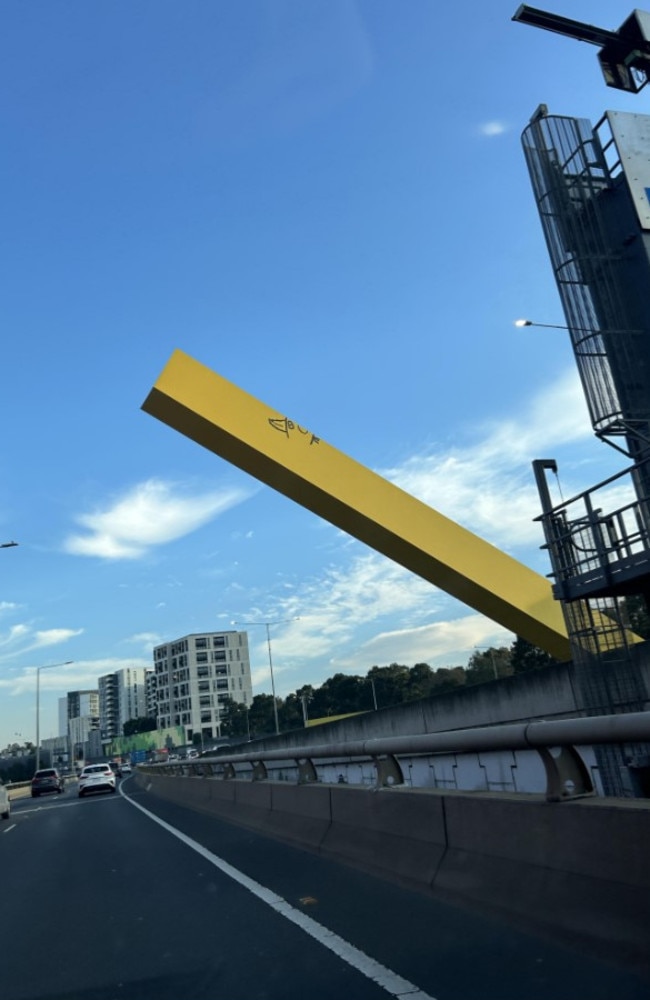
left=534, top=460, right=650, bottom=795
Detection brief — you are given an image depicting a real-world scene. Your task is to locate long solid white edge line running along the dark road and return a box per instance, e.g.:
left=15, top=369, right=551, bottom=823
left=120, top=788, right=435, bottom=1000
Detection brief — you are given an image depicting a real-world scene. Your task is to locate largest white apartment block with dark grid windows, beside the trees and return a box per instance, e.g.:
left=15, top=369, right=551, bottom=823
left=153, top=632, right=253, bottom=742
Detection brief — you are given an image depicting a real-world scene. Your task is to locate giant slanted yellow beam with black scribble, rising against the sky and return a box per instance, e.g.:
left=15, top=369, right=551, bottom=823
left=142, top=351, right=570, bottom=660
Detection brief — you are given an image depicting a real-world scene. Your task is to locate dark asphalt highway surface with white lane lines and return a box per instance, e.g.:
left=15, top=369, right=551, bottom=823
left=0, top=778, right=650, bottom=1000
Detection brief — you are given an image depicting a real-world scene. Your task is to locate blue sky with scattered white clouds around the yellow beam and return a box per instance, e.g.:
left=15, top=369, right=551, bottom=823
left=0, top=0, right=647, bottom=746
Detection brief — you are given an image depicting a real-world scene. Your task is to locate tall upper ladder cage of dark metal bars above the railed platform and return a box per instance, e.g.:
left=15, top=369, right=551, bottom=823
left=522, top=115, right=648, bottom=453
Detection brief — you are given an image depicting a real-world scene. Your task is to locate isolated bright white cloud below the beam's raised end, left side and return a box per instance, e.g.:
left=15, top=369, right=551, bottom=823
left=64, top=479, right=250, bottom=559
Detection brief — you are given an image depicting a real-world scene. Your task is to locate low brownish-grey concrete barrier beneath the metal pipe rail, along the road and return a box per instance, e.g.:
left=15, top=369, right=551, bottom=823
left=135, top=771, right=650, bottom=974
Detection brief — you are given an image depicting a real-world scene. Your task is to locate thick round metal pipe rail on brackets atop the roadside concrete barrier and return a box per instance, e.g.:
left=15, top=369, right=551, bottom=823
left=138, top=712, right=650, bottom=802
